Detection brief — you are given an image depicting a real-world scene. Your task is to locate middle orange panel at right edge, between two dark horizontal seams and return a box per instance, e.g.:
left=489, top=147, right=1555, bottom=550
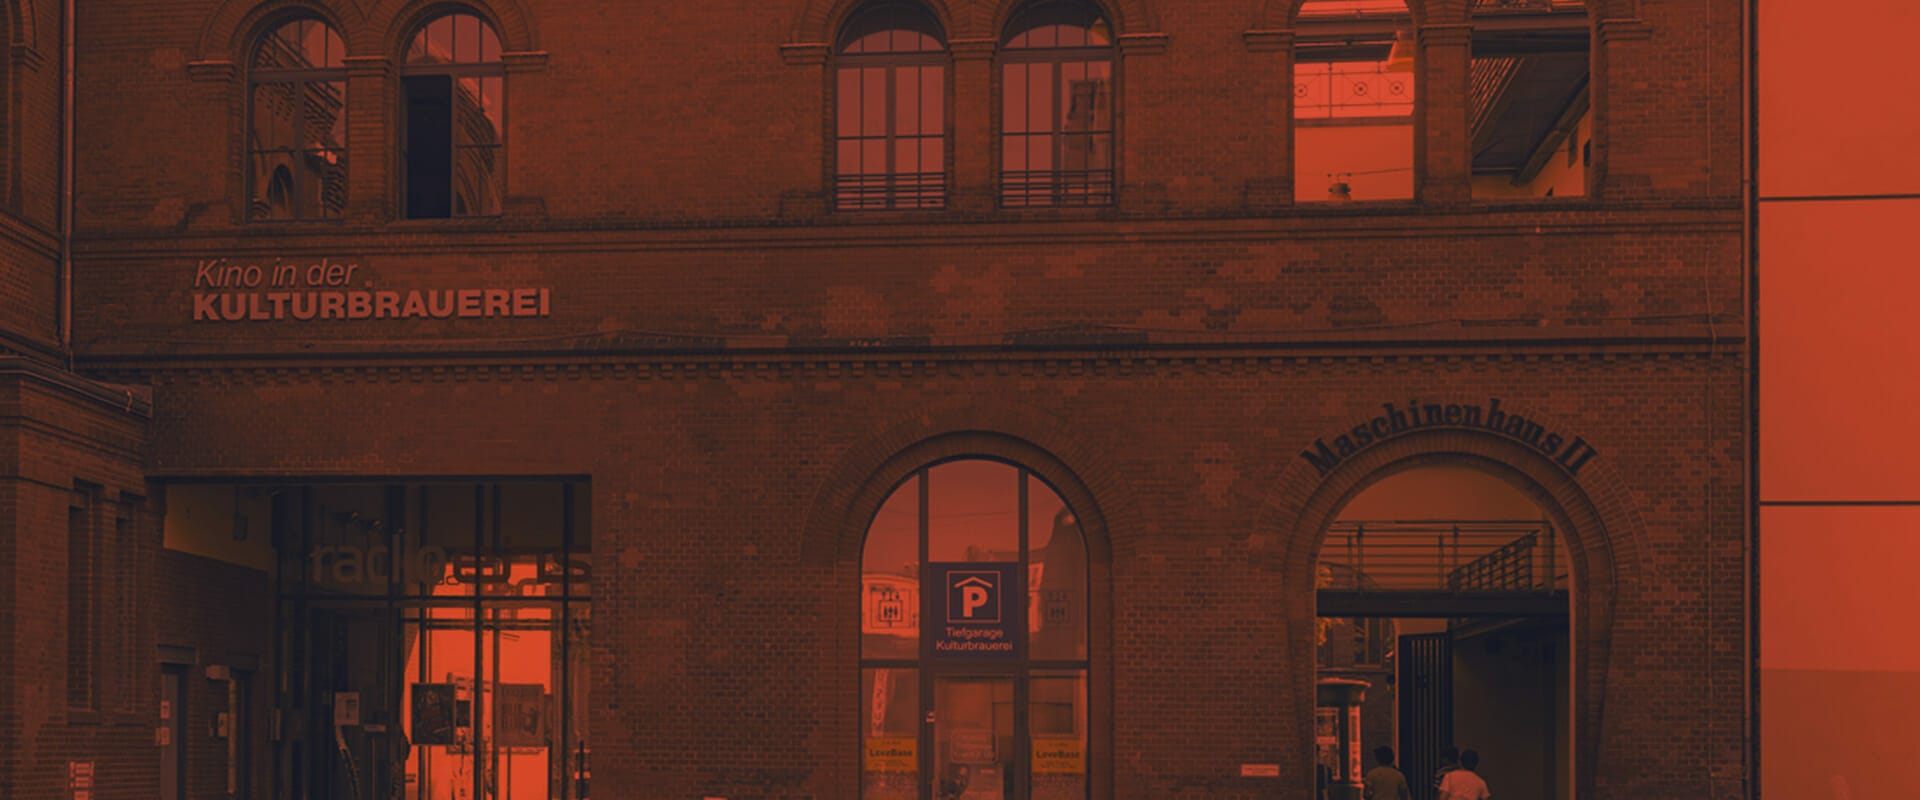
left=1759, top=200, right=1920, bottom=501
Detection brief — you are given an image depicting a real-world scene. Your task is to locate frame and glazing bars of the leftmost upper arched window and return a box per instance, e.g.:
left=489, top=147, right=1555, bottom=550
left=240, top=13, right=353, bottom=223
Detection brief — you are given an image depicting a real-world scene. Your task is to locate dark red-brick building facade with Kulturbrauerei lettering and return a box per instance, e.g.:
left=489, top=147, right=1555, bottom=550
left=0, top=0, right=1749, bottom=800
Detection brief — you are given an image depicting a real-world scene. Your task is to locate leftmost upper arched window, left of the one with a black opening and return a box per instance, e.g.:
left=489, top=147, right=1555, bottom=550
left=248, top=19, right=348, bottom=219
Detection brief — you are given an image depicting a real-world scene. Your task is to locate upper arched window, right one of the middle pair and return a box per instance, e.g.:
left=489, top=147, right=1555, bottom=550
left=1000, top=0, right=1114, bottom=207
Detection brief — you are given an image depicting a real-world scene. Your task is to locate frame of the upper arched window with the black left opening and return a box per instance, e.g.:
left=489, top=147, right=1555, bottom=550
left=392, top=6, right=511, bottom=221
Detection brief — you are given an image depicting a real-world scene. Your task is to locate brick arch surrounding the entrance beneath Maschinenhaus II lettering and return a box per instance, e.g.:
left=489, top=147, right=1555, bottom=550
left=1256, top=405, right=1647, bottom=796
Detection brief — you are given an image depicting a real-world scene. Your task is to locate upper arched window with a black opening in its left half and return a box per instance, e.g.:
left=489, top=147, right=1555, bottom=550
left=399, top=12, right=507, bottom=219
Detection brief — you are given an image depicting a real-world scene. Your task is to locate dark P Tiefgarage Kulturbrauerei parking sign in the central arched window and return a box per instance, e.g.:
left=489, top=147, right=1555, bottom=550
left=924, top=562, right=1027, bottom=658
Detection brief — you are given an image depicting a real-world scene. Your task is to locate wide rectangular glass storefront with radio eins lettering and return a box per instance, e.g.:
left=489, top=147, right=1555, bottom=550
left=276, top=482, right=591, bottom=800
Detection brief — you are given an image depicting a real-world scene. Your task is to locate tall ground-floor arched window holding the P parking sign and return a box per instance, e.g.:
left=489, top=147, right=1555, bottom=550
left=860, top=459, right=1089, bottom=800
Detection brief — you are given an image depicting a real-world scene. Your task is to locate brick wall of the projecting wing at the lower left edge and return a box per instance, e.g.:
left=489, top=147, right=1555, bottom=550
left=0, top=361, right=157, bottom=800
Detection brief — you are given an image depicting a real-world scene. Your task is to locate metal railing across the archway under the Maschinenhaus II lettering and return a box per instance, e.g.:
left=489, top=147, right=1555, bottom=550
left=1321, top=520, right=1569, bottom=591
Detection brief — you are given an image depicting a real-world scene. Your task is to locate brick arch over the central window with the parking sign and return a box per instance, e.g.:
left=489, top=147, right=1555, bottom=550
left=801, top=403, right=1137, bottom=570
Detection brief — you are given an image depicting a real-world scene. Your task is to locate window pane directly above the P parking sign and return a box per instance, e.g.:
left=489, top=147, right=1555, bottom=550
left=927, top=459, right=1020, bottom=562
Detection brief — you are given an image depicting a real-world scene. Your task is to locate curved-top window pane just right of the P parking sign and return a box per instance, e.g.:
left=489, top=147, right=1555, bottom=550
left=1027, top=476, right=1087, bottom=660
